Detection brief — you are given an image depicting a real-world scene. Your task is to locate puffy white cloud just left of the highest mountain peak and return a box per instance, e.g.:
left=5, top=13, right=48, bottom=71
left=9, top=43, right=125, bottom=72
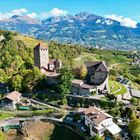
left=41, top=8, right=68, bottom=18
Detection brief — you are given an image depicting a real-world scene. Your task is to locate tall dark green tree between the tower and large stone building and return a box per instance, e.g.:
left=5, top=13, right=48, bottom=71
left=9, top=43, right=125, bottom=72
left=57, top=67, right=73, bottom=95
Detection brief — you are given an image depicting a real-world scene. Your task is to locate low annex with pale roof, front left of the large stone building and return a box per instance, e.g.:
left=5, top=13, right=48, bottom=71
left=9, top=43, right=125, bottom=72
left=71, top=79, right=96, bottom=96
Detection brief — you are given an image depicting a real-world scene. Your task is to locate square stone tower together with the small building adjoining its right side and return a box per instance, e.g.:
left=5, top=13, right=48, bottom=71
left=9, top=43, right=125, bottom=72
left=34, top=43, right=62, bottom=72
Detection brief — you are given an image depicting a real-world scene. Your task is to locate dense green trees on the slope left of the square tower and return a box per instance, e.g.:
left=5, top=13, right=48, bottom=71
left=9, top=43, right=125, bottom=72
left=0, top=31, right=43, bottom=91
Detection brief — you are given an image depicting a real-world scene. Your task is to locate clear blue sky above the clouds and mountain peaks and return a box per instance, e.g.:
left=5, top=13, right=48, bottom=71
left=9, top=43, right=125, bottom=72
left=0, top=0, right=140, bottom=22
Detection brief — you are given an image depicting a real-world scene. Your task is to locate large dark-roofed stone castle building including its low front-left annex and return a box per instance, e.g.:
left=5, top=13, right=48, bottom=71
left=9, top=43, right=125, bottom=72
left=71, top=61, right=110, bottom=95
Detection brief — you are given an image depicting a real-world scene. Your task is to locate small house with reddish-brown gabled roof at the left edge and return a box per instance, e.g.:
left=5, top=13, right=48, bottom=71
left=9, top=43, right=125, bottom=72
left=1, top=91, right=21, bottom=109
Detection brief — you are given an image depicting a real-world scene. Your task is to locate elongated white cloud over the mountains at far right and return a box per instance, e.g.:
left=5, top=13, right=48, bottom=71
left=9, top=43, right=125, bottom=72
left=105, top=14, right=137, bottom=28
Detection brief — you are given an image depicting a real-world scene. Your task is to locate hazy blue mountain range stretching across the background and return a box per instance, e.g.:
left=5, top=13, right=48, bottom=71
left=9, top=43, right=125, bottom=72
left=0, top=12, right=140, bottom=50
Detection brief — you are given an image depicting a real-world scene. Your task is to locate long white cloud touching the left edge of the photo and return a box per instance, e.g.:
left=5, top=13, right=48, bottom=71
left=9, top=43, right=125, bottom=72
left=0, top=8, right=28, bottom=20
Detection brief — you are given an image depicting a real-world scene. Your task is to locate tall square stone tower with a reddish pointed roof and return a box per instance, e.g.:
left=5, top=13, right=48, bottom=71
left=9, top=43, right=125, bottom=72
left=34, top=43, right=49, bottom=69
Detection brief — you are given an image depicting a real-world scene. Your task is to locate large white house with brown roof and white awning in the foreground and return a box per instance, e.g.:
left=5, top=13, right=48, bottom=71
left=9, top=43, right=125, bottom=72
left=78, top=106, right=121, bottom=137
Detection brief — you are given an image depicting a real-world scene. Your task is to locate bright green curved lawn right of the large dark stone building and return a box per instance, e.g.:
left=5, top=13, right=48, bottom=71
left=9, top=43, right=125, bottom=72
left=109, top=81, right=127, bottom=95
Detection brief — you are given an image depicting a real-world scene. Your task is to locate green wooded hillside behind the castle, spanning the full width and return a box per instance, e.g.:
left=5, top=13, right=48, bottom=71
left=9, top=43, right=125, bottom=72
left=0, top=31, right=140, bottom=91
